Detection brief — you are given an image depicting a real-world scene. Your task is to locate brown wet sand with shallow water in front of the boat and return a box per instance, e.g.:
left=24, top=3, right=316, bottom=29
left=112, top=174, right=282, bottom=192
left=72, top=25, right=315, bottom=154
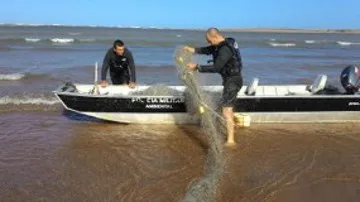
left=0, top=112, right=360, bottom=201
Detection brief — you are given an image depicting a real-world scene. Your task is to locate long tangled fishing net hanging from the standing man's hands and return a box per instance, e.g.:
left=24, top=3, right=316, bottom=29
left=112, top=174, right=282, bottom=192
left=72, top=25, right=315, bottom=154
left=174, top=47, right=225, bottom=202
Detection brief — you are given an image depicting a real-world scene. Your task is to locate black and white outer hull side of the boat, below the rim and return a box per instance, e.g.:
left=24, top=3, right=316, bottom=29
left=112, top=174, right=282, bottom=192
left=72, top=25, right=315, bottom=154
left=55, top=92, right=360, bottom=124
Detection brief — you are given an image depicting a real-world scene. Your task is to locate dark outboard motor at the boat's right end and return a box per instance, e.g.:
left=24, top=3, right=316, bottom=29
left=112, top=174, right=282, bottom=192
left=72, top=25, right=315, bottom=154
left=340, top=65, right=360, bottom=94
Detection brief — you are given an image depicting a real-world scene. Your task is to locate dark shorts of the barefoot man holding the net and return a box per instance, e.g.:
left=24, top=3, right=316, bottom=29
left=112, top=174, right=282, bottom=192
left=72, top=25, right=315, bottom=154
left=220, top=76, right=243, bottom=107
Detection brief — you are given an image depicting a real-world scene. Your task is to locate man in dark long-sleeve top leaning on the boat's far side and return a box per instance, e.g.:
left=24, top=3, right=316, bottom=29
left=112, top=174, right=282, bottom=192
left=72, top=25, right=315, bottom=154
left=100, top=40, right=136, bottom=88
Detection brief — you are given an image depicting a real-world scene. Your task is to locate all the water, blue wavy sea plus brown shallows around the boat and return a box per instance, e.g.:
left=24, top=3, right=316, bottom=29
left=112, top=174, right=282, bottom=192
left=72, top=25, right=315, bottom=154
left=0, top=25, right=360, bottom=201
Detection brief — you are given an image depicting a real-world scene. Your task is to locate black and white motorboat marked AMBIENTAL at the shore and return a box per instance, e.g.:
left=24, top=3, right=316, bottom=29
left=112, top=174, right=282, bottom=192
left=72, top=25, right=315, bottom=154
left=53, top=71, right=360, bottom=124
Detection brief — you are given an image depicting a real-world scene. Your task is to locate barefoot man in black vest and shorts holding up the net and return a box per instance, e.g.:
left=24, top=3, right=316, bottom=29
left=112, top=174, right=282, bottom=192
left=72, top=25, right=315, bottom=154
left=184, top=28, right=243, bottom=145
